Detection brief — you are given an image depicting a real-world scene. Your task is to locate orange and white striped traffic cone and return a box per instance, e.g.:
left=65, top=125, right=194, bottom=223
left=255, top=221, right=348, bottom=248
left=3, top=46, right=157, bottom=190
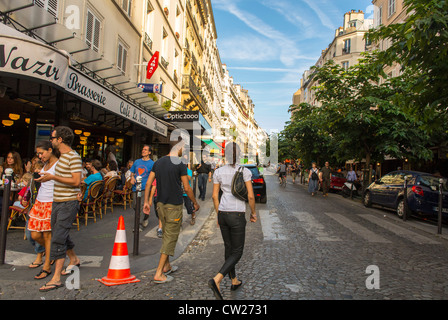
left=98, top=216, right=140, bottom=286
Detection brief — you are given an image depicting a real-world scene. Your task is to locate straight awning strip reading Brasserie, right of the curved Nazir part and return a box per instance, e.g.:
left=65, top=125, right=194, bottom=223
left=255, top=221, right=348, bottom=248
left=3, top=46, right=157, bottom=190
left=65, top=68, right=168, bottom=137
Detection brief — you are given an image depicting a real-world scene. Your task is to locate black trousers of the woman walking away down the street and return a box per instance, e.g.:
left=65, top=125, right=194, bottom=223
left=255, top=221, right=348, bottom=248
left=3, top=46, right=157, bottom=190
left=218, top=211, right=246, bottom=278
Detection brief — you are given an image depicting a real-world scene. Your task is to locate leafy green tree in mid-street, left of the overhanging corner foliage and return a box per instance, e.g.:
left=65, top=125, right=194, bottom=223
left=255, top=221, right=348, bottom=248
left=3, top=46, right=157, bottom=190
left=314, top=53, right=432, bottom=172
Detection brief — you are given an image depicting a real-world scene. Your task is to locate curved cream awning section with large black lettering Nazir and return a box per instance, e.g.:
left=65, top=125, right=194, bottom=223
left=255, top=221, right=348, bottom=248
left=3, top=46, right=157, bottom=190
left=0, top=35, right=69, bottom=87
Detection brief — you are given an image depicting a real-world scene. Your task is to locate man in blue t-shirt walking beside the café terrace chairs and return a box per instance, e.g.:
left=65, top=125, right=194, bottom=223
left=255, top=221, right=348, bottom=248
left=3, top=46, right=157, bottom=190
left=129, top=144, right=154, bottom=227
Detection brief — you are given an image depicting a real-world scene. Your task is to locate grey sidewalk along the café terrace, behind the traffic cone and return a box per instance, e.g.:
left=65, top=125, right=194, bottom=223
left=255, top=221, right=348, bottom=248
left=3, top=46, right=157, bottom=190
left=0, top=183, right=213, bottom=299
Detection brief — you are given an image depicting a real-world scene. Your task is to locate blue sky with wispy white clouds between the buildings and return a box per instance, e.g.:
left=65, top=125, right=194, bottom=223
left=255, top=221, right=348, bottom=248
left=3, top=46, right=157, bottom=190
left=211, top=0, right=373, bottom=134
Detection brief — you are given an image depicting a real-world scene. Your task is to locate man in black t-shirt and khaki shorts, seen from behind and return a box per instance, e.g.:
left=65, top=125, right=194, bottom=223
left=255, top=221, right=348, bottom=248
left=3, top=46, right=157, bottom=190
left=143, top=142, right=199, bottom=283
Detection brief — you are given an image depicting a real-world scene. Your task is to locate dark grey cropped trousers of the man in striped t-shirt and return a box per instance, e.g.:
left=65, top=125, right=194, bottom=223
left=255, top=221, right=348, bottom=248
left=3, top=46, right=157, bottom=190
left=50, top=200, right=79, bottom=260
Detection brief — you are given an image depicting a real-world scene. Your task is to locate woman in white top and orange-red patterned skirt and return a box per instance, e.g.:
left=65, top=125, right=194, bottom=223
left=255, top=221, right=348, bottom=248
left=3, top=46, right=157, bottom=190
left=28, top=141, right=59, bottom=279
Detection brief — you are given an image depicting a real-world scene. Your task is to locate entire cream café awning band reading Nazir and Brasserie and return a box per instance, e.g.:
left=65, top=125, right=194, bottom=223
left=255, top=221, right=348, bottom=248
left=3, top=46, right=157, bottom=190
left=0, top=35, right=168, bottom=137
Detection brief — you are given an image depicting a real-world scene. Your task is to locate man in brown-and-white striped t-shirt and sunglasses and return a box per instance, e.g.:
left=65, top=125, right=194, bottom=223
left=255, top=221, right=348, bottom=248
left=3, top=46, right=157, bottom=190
left=35, top=126, right=82, bottom=292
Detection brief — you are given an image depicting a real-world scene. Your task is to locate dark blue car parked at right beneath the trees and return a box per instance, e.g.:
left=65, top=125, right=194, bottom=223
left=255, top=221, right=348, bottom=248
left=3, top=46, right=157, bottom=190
left=364, top=171, right=448, bottom=218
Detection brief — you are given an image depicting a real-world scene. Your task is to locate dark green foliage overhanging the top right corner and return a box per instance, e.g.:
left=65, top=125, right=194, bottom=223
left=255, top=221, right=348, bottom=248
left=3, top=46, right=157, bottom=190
left=368, top=0, right=448, bottom=125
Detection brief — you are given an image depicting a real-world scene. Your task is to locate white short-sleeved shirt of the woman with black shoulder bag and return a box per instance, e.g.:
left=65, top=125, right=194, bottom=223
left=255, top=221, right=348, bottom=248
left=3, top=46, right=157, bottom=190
left=213, top=165, right=252, bottom=212
